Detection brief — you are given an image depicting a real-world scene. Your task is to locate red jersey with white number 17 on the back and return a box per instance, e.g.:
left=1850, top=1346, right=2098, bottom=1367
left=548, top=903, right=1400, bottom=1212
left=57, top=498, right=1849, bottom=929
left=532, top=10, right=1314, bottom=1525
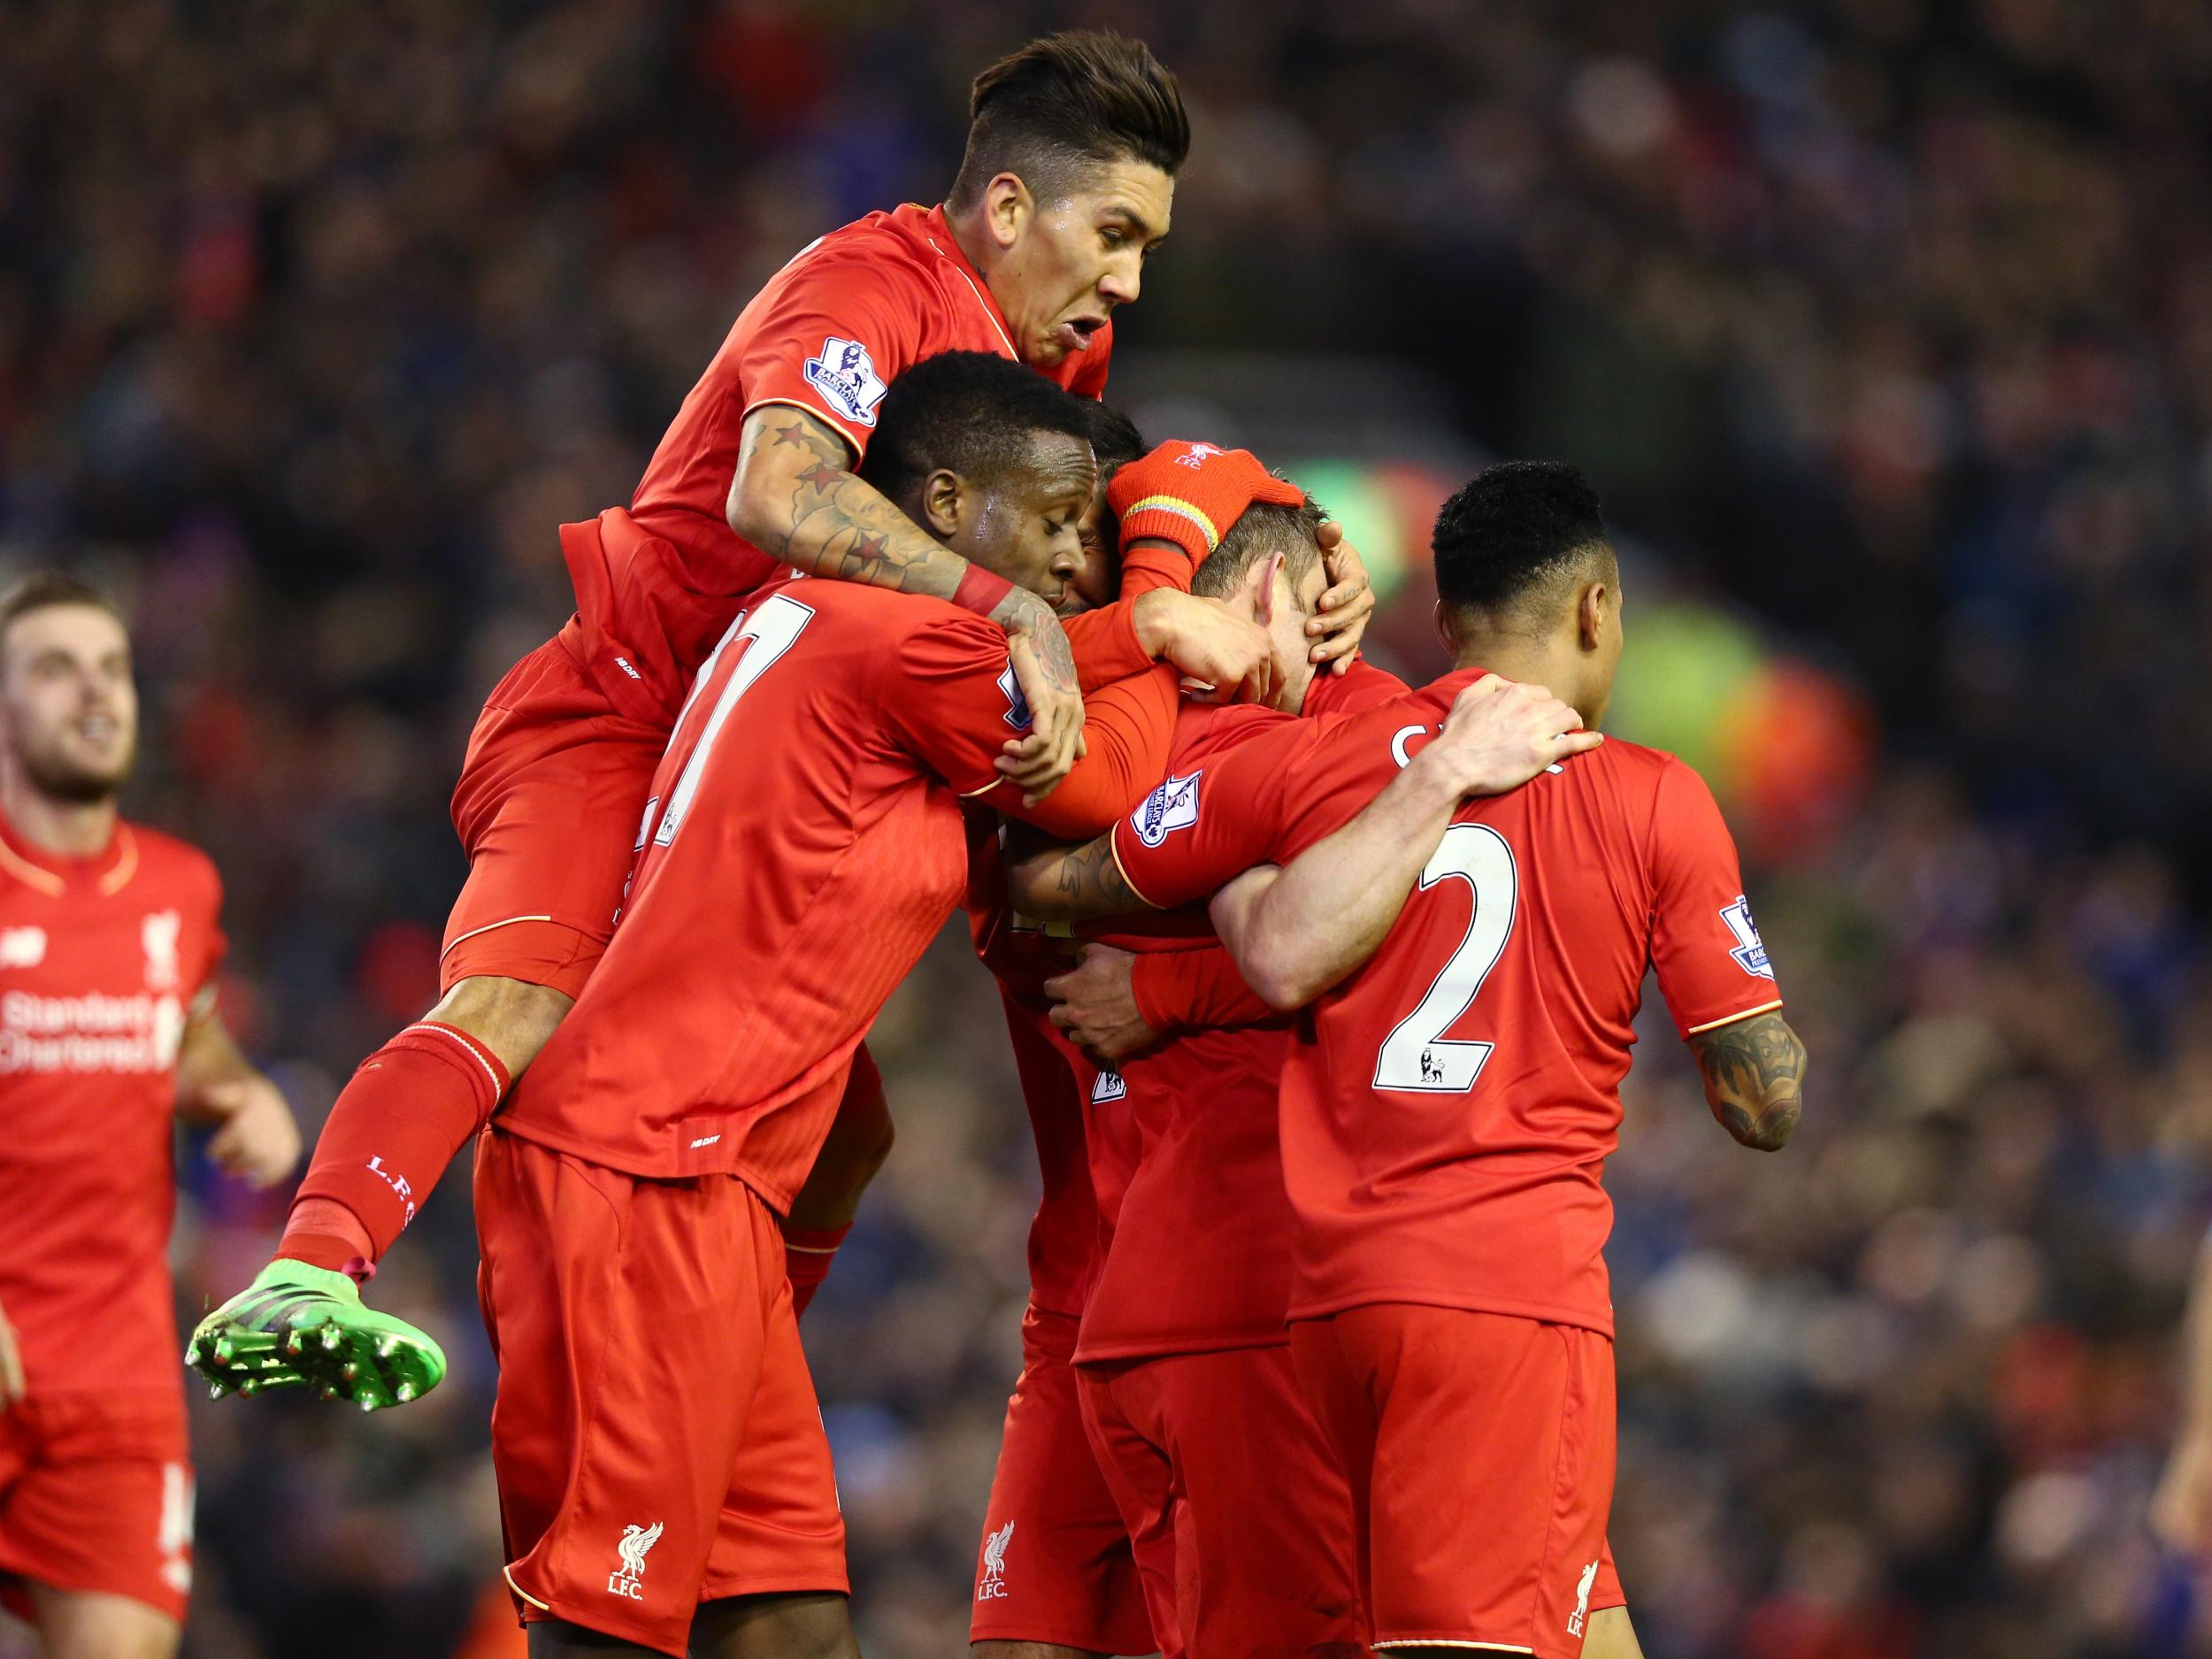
left=498, top=578, right=1175, bottom=1212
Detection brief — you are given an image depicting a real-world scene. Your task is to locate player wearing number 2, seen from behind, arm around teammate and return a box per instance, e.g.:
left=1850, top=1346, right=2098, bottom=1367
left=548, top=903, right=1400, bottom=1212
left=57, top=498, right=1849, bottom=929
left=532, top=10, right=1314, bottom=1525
left=1029, top=465, right=1805, bottom=1659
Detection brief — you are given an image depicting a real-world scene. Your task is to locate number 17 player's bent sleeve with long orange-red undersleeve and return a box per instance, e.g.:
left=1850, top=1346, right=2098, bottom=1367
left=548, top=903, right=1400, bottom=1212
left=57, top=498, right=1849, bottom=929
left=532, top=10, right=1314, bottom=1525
left=883, top=618, right=1177, bottom=839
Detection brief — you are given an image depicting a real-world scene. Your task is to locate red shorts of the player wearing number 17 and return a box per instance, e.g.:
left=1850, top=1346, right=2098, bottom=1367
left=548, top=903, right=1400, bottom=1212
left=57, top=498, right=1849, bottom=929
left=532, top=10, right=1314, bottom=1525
left=476, top=1131, right=848, bottom=1655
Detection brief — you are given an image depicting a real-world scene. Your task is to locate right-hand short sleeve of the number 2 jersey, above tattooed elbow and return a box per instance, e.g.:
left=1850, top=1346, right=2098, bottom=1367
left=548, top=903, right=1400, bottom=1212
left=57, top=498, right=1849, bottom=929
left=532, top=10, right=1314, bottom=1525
left=1650, top=759, right=1783, bottom=1038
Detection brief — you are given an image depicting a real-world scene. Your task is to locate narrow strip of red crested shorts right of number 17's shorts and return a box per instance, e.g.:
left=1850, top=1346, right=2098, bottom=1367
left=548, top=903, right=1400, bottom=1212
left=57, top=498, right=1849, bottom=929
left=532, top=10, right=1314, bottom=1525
left=969, top=1308, right=1157, bottom=1653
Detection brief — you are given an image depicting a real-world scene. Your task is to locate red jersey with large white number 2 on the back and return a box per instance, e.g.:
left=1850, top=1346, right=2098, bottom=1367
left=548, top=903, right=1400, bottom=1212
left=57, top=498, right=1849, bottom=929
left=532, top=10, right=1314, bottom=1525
left=1113, top=668, right=1781, bottom=1334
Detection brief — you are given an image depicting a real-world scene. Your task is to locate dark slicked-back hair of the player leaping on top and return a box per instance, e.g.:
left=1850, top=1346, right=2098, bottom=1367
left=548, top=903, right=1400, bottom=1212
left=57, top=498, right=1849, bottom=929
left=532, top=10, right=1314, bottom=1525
left=949, top=29, right=1190, bottom=208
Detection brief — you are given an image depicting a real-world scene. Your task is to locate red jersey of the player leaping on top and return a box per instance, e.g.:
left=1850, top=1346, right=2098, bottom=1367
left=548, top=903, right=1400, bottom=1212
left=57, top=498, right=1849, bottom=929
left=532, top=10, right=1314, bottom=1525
left=562, top=204, right=1113, bottom=719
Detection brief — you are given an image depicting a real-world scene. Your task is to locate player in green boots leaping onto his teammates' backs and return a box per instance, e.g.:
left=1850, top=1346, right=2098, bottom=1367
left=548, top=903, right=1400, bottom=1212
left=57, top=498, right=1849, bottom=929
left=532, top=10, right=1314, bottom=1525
left=195, top=34, right=1371, bottom=1405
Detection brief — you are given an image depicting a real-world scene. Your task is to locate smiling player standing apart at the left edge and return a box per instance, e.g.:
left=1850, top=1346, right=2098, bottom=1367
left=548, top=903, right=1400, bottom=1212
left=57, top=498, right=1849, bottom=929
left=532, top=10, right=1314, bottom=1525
left=0, top=573, right=299, bottom=1659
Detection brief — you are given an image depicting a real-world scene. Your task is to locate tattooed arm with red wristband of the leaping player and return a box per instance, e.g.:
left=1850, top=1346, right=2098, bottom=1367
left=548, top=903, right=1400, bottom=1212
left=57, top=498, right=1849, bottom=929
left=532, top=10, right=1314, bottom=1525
left=728, top=403, right=1084, bottom=752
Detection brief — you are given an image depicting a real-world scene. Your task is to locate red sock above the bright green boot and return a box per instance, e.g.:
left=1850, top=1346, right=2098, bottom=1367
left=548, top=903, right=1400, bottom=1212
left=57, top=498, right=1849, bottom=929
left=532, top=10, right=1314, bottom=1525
left=277, top=1020, right=509, bottom=1279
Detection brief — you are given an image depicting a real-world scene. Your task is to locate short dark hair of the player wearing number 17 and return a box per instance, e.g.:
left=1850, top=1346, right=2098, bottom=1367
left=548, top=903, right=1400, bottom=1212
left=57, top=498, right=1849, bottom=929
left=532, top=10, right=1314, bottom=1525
left=861, top=352, right=1093, bottom=503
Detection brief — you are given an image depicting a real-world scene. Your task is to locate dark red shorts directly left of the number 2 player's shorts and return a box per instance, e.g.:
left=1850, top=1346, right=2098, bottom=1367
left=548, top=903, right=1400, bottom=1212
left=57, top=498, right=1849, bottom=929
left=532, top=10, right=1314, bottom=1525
left=1078, top=1345, right=1367, bottom=1659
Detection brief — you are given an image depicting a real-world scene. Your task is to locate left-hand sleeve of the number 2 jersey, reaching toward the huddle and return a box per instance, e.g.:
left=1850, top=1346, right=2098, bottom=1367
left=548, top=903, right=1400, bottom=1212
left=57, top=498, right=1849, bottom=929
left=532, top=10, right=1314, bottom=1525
left=1113, top=721, right=1312, bottom=910
